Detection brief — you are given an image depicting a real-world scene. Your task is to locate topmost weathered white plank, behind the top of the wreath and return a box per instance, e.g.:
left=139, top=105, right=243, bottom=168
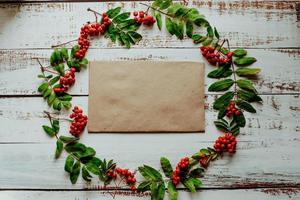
left=0, top=0, right=300, bottom=49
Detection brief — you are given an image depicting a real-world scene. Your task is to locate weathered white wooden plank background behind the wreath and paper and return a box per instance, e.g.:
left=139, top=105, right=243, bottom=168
left=0, top=0, right=300, bottom=200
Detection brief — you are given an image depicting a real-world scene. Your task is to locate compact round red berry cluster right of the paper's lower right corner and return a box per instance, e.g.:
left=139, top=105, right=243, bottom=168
left=214, top=132, right=237, bottom=153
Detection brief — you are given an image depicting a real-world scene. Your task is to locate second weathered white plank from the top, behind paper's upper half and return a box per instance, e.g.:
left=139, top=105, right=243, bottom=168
left=0, top=49, right=300, bottom=95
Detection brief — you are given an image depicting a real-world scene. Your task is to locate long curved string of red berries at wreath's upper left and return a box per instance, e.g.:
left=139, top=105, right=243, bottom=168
left=75, top=13, right=111, bottom=59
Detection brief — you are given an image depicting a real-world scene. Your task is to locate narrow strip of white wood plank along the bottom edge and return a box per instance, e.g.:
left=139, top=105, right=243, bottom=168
left=0, top=188, right=300, bottom=200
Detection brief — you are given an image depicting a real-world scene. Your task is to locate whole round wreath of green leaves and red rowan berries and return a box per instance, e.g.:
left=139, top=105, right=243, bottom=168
left=38, top=0, right=262, bottom=200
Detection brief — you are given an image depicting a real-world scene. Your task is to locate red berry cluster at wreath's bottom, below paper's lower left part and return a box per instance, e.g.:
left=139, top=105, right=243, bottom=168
left=107, top=168, right=136, bottom=191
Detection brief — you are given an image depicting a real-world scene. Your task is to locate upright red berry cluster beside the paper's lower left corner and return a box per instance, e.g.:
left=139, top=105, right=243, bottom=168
left=70, top=106, right=88, bottom=137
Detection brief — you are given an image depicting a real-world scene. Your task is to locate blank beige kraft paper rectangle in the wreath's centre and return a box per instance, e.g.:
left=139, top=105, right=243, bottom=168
left=88, top=61, right=205, bottom=132
